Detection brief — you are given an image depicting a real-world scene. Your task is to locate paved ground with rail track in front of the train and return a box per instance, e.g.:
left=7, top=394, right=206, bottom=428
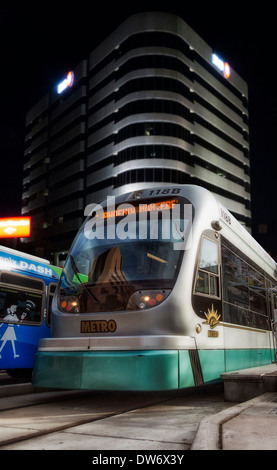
left=0, top=387, right=230, bottom=451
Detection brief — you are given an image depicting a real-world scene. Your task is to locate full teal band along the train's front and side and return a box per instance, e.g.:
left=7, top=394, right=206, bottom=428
left=33, top=349, right=272, bottom=391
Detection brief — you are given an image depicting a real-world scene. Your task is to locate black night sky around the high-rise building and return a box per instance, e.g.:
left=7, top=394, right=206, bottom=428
left=0, top=0, right=277, bottom=258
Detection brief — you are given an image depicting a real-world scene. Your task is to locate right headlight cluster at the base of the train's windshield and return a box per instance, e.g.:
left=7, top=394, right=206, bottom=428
left=127, top=289, right=171, bottom=310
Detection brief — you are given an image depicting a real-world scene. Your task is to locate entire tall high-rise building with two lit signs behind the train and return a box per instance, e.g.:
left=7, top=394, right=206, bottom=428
left=22, top=13, right=251, bottom=262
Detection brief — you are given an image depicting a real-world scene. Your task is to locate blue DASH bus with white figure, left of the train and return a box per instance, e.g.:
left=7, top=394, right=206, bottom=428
left=0, top=246, right=62, bottom=378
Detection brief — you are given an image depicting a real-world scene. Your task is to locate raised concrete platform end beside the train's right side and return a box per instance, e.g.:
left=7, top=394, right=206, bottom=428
left=220, top=364, right=277, bottom=403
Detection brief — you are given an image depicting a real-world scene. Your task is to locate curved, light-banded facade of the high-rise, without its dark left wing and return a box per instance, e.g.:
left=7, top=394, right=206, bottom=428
left=87, top=13, right=250, bottom=222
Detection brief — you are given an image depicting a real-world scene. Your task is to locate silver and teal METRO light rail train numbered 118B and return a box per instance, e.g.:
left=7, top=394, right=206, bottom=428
left=33, top=185, right=277, bottom=391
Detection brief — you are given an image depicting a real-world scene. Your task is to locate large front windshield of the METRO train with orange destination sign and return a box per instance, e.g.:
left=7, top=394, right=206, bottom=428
left=59, top=199, right=191, bottom=313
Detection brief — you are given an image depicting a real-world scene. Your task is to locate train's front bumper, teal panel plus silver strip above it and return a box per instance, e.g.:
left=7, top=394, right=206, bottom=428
left=32, top=336, right=195, bottom=391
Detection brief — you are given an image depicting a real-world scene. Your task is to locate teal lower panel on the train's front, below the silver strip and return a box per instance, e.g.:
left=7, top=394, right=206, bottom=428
left=33, top=350, right=194, bottom=391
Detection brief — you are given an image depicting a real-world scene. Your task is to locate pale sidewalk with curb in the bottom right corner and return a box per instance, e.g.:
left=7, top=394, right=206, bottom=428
left=191, top=392, right=277, bottom=450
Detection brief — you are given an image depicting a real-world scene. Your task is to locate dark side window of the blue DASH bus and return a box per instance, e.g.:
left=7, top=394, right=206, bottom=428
left=0, top=273, right=44, bottom=325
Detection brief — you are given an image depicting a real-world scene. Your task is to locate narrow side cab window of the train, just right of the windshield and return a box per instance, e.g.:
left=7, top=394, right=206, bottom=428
left=195, top=237, right=219, bottom=297
